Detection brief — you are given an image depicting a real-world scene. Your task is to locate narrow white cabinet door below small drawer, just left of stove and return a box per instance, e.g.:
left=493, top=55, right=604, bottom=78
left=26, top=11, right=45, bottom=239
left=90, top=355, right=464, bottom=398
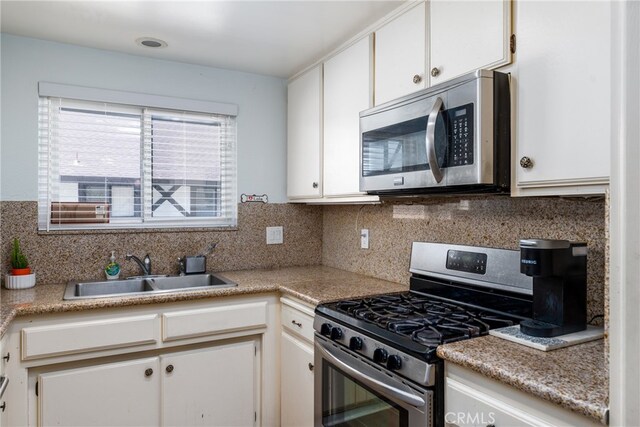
left=280, top=332, right=313, bottom=427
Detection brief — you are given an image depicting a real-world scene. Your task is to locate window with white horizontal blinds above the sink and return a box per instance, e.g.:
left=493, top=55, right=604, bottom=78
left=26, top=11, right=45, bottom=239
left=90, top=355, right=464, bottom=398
left=39, top=86, right=237, bottom=230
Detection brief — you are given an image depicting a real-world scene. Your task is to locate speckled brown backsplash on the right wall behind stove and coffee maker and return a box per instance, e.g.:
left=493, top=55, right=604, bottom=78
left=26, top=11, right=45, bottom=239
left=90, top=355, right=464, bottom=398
left=322, top=196, right=606, bottom=319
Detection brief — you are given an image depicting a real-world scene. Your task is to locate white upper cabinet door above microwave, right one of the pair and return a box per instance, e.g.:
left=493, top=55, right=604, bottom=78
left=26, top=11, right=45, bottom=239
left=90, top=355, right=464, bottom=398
left=429, top=0, right=512, bottom=85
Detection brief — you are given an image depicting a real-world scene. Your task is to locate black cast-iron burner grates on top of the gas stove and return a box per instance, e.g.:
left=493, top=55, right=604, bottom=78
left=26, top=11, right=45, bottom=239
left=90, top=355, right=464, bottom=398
left=335, top=293, right=514, bottom=347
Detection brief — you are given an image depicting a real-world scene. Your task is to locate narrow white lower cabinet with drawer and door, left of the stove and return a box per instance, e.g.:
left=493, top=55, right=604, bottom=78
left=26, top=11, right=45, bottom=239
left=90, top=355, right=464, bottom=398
left=280, top=298, right=315, bottom=427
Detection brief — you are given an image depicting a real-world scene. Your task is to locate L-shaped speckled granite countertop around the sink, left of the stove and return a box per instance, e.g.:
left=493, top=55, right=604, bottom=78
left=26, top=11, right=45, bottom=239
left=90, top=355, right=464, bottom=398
left=0, top=266, right=409, bottom=337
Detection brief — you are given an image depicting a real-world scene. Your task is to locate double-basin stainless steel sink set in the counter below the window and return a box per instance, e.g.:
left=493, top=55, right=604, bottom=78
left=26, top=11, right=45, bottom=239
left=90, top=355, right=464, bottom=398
left=64, top=274, right=238, bottom=300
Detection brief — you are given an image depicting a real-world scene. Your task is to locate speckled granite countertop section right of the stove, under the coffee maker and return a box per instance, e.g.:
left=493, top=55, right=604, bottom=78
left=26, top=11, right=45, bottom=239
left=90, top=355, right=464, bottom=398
left=438, top=336, right=609, bottom=424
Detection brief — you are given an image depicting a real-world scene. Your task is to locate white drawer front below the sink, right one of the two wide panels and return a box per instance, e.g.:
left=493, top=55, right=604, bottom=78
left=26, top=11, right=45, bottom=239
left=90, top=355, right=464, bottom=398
left=162, top=302, right=267, bottom=341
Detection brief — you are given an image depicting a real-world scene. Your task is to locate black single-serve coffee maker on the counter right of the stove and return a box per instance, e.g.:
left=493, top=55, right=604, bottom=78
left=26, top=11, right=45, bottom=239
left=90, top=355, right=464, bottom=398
left=520, top=239, right=587, bottom=337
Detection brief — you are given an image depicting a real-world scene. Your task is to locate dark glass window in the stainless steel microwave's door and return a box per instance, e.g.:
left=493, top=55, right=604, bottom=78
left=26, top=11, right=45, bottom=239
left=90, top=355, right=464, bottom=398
left=362, top=114, right=447, bottom=176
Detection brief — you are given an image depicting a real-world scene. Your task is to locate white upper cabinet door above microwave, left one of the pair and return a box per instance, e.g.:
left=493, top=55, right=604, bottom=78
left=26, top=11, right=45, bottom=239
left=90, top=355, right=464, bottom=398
left=374, top=3, right=428, bottom=105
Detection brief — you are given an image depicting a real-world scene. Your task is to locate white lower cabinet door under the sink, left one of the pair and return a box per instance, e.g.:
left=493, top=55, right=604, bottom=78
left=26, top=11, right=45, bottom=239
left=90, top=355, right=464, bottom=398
left=38, top=357, right=160, bottom=426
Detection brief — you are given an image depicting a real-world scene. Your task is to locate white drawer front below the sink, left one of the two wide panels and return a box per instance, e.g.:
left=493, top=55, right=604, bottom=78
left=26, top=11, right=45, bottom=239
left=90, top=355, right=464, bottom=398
left=21, top=314, right=159, bottom=360
